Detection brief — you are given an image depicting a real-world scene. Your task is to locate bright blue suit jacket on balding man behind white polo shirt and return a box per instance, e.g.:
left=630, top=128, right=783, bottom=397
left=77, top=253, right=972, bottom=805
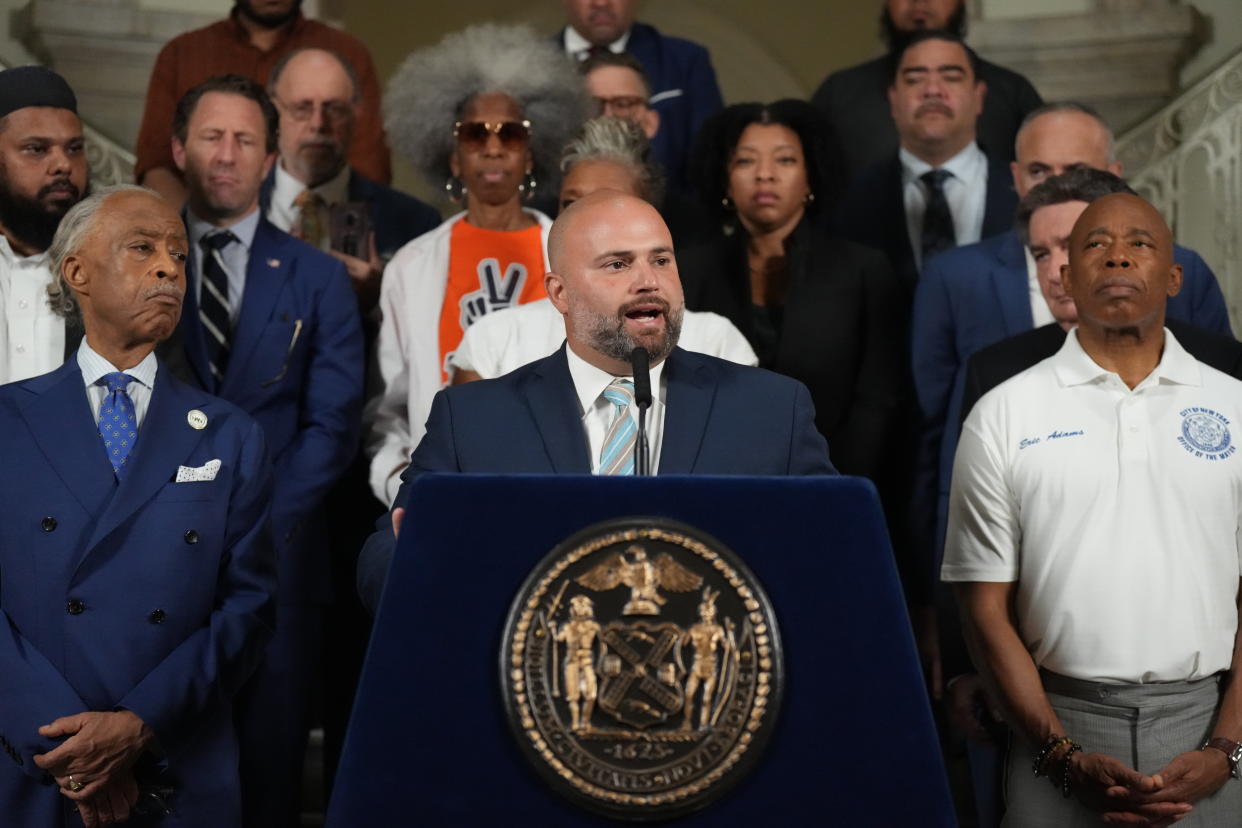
left=910, top=230, right=1232, bottom=578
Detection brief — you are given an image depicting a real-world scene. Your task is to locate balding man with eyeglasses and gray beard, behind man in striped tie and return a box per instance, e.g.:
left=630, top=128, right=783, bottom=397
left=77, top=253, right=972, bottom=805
left=260, top=48, right=440, bottom=313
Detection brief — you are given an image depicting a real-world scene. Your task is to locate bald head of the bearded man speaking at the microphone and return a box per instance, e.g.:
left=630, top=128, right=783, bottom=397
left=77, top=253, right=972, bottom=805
left=544, top=190, right=684, bottom=376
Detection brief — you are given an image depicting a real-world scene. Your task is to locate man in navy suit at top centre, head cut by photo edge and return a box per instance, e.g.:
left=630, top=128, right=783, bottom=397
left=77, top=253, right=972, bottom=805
left=556, top=0, right=724, bottom=187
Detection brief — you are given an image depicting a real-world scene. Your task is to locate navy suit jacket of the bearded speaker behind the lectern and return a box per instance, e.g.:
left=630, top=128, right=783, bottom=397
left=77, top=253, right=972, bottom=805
left=358, top=345, right=836, bottom=612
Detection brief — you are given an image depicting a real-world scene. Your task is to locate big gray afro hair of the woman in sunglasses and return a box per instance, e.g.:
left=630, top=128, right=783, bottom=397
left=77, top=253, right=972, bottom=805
left=384, top=24, right=587, bottom=190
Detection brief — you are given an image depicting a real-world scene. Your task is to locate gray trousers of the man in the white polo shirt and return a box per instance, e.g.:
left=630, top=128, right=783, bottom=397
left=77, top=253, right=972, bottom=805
left=1002, top=672, right=1242, bottom=828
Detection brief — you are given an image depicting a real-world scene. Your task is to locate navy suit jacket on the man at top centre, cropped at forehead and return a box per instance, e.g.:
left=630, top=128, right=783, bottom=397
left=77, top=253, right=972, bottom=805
left=598, top=22, right=724, bottom=189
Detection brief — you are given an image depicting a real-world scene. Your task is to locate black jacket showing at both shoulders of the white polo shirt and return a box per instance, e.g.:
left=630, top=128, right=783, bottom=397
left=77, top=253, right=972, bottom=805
left=958, top=319, right=1242, bottom=427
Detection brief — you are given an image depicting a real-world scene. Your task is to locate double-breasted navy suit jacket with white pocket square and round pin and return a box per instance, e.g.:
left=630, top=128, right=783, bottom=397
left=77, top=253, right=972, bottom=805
left=0, top=359, right=276, bottom=826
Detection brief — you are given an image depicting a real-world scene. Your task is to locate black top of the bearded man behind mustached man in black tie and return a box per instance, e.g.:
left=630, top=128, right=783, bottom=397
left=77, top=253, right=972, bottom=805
left=811, top=55, right=1043, bottom=184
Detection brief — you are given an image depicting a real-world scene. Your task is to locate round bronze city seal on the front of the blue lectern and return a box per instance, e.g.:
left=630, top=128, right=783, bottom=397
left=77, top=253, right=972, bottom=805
left=501, top=518, right=784, bottom=821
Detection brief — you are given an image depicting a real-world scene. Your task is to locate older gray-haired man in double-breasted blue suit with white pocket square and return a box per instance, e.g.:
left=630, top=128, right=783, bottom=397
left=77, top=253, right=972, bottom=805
left=0, top=187, right=276, bottom=828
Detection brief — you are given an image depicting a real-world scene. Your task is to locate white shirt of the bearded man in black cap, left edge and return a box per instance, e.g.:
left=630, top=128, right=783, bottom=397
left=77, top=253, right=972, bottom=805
left=0, top=236, right=65, bottom=385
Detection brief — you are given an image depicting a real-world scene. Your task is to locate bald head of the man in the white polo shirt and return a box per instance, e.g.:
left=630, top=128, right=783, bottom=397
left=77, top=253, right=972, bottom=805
left=1062, top=192, right=1181, bottom=334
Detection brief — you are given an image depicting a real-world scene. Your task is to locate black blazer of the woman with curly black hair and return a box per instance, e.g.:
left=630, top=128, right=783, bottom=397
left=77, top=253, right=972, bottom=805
left=677, top=220, right=908, bottom=483
